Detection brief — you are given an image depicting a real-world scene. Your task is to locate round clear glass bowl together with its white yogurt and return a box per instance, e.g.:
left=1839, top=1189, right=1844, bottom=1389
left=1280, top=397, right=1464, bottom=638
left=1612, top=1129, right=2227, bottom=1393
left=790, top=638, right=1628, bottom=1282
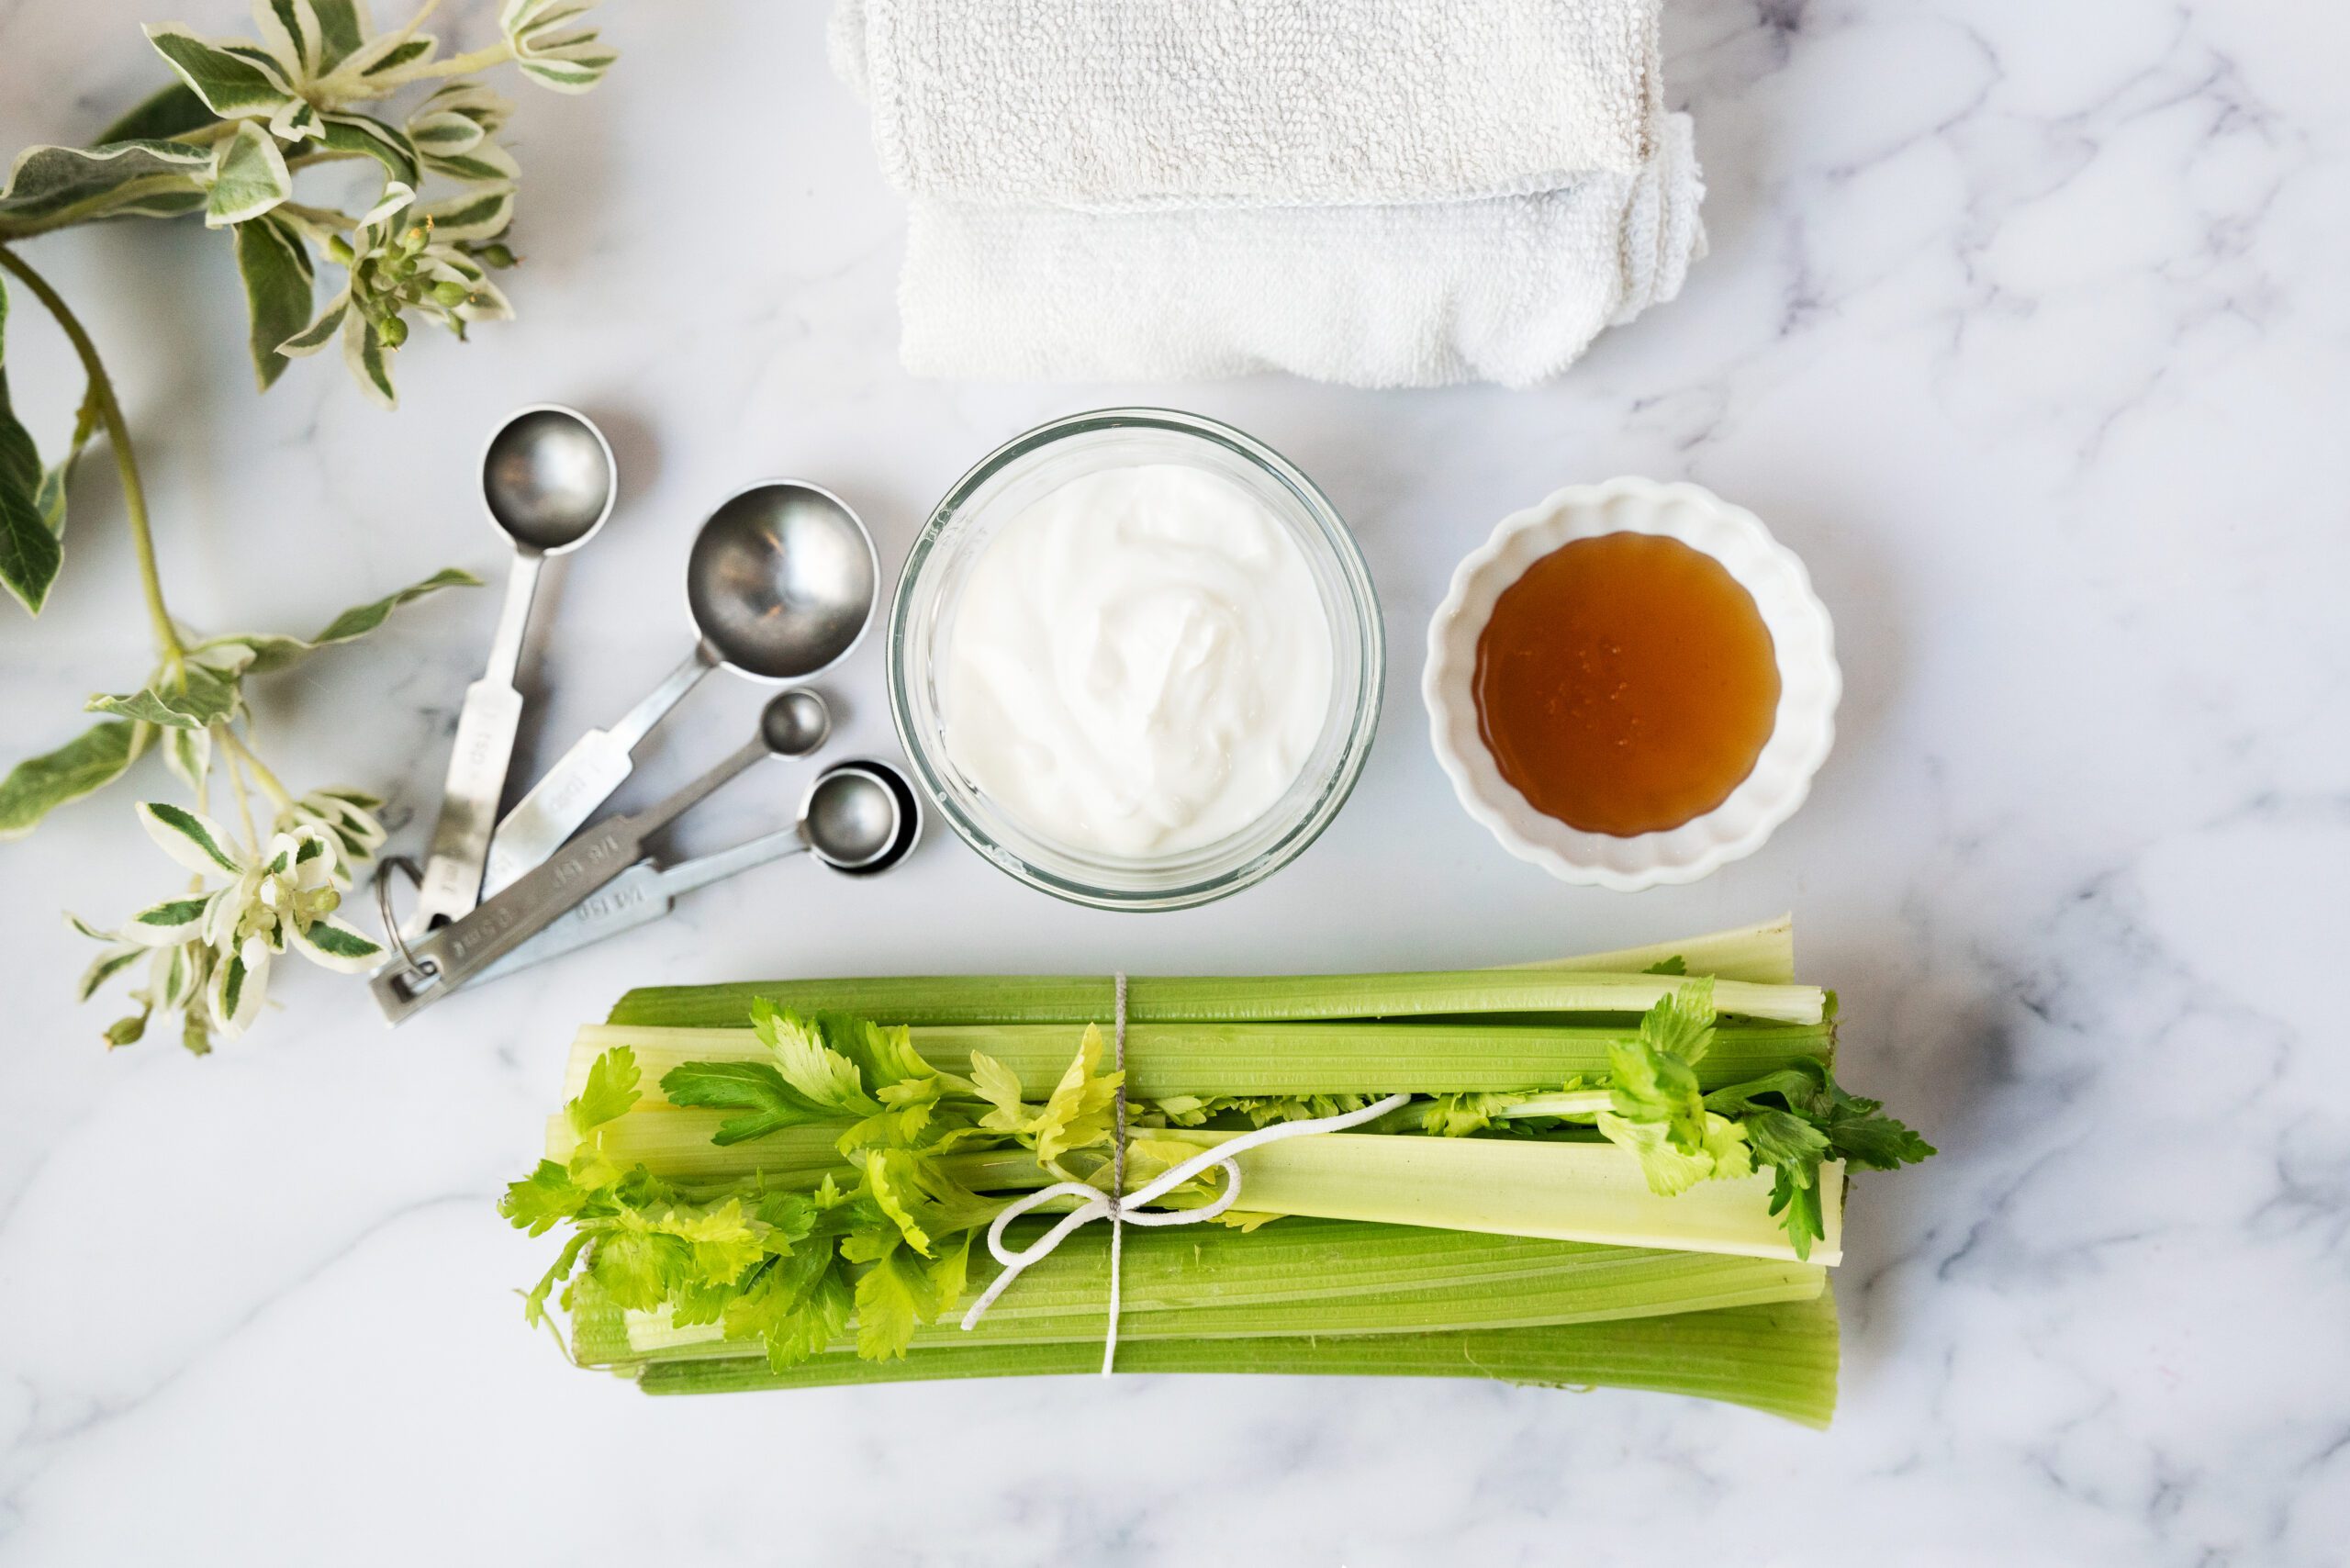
left=890, top=409, right=1384, bottom=910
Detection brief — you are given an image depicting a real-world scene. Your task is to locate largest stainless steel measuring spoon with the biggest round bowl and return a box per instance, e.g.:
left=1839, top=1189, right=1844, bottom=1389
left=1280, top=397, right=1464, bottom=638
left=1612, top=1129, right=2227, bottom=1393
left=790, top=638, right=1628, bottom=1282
left=482, top=479, right=881, bottom=893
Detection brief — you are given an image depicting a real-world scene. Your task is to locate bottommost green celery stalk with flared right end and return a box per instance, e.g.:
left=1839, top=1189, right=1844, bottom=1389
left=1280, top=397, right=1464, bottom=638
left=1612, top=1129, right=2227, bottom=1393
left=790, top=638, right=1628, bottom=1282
left=637, top=1293, right=1838, bottom=1427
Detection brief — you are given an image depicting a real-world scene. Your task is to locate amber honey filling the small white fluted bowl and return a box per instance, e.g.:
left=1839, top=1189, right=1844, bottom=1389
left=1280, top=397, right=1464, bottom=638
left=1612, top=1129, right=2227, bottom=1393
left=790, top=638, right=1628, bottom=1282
left=1473, top=533, right=1779, bottom=837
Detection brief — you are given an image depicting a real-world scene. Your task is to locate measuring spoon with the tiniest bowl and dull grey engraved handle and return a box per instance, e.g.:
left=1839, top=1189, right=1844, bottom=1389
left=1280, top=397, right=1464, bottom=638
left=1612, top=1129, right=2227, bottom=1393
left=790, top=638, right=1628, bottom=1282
left=366, top=687, right=832, bottom=1023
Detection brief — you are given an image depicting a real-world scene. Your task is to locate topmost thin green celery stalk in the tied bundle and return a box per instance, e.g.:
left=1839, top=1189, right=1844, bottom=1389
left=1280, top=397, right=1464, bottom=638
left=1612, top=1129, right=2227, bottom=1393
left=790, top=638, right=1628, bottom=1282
left=609, top=969, right=1826, bottom=1027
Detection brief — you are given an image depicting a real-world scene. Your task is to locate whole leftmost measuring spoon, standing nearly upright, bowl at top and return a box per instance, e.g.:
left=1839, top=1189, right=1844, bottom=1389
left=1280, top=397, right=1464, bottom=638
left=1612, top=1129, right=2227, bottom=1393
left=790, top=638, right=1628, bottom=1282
left=407, top=402, right=616, bottom=935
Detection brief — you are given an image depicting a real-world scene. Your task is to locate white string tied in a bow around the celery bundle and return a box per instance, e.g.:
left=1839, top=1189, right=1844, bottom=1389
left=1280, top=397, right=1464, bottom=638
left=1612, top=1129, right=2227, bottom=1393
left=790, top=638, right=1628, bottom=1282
left=964, top=976, right=1413, bottom=1378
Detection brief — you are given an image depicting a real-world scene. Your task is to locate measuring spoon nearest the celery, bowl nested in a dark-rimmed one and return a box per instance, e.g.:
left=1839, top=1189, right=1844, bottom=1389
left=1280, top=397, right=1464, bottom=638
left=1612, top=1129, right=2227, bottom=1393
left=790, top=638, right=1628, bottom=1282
left=475, top=762, right=922, bottom=985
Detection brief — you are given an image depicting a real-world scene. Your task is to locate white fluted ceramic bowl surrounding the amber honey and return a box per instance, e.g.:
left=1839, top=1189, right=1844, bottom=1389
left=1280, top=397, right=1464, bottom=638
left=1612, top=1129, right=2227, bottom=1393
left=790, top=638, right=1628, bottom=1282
left=1419, top=477, right=1845, bottom=893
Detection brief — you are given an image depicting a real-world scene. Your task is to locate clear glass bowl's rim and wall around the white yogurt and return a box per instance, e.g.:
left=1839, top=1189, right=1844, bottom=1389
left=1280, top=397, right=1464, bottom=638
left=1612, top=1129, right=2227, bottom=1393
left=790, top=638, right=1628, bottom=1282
left=889, top=409, right=1386, bottom=910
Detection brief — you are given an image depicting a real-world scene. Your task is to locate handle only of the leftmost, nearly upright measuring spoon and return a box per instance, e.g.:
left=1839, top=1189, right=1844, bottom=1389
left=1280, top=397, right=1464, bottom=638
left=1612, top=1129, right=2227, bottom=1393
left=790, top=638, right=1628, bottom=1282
left=408, top=550, right=543, bottom=935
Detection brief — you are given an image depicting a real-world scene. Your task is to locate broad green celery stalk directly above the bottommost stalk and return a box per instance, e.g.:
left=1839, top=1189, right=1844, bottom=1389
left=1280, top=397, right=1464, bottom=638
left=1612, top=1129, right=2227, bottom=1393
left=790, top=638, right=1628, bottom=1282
left=571, top=1220, right=1829, bottom=1366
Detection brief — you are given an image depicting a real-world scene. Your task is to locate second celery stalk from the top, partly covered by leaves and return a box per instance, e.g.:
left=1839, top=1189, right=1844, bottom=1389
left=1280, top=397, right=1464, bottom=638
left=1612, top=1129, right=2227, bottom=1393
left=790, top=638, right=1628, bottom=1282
left=564, top=1023, right=1835, bottom=1103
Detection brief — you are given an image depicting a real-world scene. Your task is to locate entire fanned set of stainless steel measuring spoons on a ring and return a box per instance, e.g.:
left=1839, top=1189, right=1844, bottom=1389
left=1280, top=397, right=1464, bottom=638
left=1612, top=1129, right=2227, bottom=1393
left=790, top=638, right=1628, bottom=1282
left=371, top=404, right=922, bottom=1023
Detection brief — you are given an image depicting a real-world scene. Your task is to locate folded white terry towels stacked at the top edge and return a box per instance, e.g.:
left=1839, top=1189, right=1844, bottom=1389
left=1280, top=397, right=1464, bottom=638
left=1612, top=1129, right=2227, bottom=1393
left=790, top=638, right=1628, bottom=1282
left=834, top=0, right=1704, bottom=386
